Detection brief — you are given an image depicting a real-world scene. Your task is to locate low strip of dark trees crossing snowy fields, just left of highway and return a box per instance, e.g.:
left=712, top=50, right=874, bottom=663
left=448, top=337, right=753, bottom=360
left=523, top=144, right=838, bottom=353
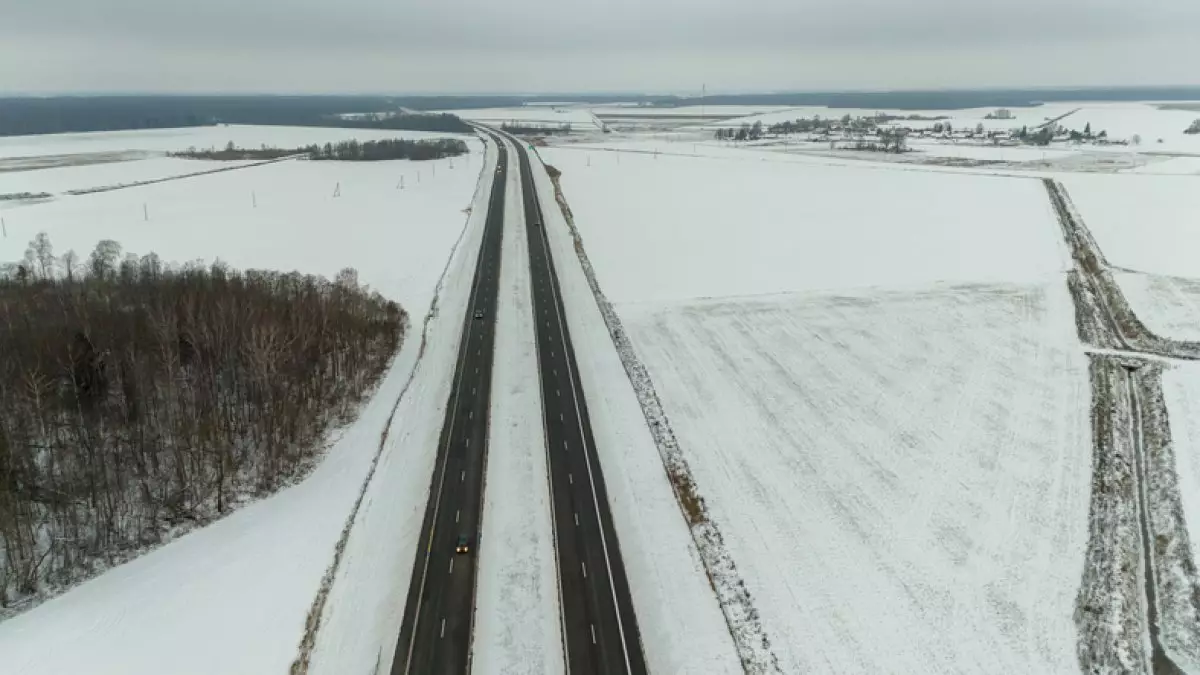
left=170, top=138, right=468, bottom=162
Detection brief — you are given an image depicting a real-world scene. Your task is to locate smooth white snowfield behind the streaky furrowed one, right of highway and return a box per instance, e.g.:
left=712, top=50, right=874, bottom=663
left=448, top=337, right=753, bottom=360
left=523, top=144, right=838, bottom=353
left=542, top=148, right=1067, bottom=303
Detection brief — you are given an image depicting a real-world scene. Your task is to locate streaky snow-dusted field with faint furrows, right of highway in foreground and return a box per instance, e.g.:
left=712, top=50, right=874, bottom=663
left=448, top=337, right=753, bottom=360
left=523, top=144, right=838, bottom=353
left=624, top=277, right=1092, bottom=674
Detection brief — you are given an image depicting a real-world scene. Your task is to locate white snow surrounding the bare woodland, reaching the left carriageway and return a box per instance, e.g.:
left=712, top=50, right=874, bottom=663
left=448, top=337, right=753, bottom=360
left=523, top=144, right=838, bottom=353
left=0, top=128, right=494, bottom=675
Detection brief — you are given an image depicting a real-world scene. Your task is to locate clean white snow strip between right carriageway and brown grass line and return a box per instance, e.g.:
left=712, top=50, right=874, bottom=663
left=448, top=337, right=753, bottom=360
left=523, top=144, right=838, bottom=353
left=532, top=148, right=743, bottom=675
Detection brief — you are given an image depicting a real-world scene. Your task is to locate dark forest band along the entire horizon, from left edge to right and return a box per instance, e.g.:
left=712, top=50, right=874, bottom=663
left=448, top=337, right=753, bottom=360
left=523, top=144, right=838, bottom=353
left=0, top=86, right=1200, bottom=136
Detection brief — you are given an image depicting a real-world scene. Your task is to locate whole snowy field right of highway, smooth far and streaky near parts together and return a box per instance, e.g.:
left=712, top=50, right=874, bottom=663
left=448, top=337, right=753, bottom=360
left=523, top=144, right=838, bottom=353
left=540, top=135, right=1092, bottom=674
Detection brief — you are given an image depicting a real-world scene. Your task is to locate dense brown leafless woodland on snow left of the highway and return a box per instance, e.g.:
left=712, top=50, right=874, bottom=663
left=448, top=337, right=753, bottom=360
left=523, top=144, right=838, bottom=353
left=0, top=234, right=408, bottom=614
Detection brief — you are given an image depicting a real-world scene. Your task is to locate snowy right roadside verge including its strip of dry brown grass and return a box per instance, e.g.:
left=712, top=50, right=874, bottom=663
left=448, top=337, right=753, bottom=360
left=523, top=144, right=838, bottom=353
left=533, top=149, right=744, bottom=674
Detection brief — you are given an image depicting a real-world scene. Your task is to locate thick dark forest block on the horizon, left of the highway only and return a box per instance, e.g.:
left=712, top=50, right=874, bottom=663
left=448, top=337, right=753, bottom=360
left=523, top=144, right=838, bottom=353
left=0, top=96, right=473, bottom=136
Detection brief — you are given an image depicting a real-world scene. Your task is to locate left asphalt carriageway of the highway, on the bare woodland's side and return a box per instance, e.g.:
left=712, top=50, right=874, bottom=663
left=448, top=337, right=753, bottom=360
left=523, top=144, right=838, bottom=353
left=391, top=143, right=508, bottom=674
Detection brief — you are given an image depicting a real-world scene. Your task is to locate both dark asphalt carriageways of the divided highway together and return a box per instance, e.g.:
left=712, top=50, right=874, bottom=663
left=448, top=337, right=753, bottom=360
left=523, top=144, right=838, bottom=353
left=391, top=130, right=647, bottom=675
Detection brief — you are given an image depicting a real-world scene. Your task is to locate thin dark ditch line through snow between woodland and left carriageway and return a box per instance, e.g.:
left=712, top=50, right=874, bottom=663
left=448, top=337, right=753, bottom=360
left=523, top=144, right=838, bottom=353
left=288, top=138, right=493, bottom=675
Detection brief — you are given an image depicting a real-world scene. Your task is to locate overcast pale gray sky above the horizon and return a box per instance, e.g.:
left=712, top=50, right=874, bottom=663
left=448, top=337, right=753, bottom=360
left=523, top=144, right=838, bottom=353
left=0, top=0, right=1200, bottom=94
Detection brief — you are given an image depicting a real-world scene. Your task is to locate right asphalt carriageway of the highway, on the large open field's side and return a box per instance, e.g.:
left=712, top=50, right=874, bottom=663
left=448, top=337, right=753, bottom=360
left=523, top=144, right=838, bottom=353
left=515, top=133, right=646, bottom=675
